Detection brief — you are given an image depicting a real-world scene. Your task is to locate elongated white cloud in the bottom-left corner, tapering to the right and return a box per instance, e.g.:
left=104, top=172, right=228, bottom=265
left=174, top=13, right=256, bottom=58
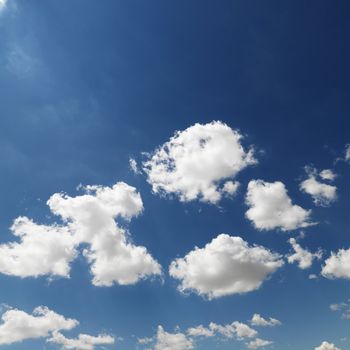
left=0, top=306, right=78, bottom=345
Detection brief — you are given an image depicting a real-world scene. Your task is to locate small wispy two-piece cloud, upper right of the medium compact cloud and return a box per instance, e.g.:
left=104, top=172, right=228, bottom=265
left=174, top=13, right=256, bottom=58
left=300, top=167, right=337, bottom=207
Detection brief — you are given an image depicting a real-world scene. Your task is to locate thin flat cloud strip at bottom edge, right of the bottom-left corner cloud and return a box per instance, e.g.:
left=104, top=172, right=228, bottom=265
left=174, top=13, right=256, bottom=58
left=47, top=331, right=115, bottom=350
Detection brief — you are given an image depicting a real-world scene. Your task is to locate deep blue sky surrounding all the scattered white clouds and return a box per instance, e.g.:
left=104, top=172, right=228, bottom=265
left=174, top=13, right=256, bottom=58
left=0, top=0, right=350, bottom=350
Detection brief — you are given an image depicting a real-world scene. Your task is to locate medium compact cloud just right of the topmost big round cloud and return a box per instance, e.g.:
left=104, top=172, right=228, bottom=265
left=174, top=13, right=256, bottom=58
left=246, top=180, right=312, bottom=231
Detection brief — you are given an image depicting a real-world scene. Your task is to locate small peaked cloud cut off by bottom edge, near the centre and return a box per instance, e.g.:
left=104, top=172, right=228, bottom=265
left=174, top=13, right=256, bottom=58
left=155, top=326, right=194, bottom=350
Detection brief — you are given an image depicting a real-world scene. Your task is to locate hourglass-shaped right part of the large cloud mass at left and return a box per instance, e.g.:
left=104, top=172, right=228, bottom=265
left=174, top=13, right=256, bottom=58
left=48, top=182, right=161, bottom=286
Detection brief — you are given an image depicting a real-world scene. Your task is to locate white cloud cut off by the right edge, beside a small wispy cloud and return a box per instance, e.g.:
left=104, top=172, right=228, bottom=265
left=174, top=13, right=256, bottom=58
left=322, top=248, right=350, bottom=279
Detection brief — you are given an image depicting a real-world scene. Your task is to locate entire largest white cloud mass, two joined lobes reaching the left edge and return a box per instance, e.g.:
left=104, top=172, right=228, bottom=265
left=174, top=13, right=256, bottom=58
left=0, top=182, right=161, bottom=286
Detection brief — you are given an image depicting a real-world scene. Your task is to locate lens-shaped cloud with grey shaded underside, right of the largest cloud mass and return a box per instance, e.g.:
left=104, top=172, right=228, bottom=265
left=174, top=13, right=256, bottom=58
left=169, top=234, right=283, bottom=299
